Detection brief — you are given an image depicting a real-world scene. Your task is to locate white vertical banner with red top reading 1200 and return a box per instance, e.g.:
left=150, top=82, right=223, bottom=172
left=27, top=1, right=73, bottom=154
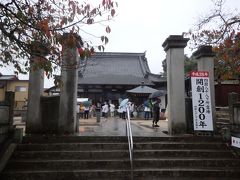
left=190, top=71, right=213, bottom=131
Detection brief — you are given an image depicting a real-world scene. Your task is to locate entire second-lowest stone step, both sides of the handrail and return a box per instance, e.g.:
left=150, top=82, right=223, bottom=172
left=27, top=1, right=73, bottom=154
left=6, top=157, right=240, bottom=171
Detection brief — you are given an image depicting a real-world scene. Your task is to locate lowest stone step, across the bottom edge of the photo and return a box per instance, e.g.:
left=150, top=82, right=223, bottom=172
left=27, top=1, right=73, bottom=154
left=0, top=168, right=240, bottom=180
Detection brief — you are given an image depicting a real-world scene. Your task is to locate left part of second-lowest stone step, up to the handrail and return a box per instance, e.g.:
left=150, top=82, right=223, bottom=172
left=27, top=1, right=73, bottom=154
left=5, top=158, right=130, bottom=171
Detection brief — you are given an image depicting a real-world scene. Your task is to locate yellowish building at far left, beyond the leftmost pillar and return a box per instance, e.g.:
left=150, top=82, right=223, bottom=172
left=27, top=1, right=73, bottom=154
left=0, top=73, right=29, bottom=109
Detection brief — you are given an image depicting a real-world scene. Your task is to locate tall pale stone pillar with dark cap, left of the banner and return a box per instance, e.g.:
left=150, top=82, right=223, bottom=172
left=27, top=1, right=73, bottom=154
left=162, top=35, right=189, bottom=134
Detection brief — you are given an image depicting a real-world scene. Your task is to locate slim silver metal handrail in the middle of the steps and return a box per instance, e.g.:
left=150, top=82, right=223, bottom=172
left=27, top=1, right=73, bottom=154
left=126, top=105, right=133, bottom=180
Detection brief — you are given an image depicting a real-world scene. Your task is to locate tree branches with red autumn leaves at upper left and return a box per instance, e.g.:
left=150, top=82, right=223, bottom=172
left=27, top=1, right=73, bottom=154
left=0, top=0, right=117, bottom=74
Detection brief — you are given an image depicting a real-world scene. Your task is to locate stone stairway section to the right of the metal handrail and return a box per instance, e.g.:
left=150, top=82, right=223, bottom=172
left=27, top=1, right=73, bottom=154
left=134, top=137, right=240, bottom=180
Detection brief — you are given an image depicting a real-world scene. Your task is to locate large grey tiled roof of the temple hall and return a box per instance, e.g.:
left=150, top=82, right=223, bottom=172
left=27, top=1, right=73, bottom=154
left=79, top=52, right=166, bottom=85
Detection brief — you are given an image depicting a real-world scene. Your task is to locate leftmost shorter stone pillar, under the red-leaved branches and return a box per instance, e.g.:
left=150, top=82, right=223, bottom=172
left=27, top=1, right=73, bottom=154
left=26, top=60, right=44, bottom=134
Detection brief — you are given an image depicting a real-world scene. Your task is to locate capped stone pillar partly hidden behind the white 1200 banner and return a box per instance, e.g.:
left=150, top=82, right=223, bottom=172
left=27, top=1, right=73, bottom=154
left=193, top=46, right=216, bottom=132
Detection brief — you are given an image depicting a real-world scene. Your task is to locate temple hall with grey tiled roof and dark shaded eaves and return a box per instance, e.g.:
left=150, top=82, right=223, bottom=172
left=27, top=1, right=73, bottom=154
left=78, top=52, right=167, bottom=104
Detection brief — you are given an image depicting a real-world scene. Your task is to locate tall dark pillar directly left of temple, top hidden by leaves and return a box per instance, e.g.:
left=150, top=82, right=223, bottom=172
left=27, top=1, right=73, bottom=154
left=58, top=34, right=79, bottom=134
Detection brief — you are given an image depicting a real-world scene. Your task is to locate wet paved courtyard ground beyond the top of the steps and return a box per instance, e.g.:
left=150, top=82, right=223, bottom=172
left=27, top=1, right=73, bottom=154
left=14, top=117, right=168, bottom=136
